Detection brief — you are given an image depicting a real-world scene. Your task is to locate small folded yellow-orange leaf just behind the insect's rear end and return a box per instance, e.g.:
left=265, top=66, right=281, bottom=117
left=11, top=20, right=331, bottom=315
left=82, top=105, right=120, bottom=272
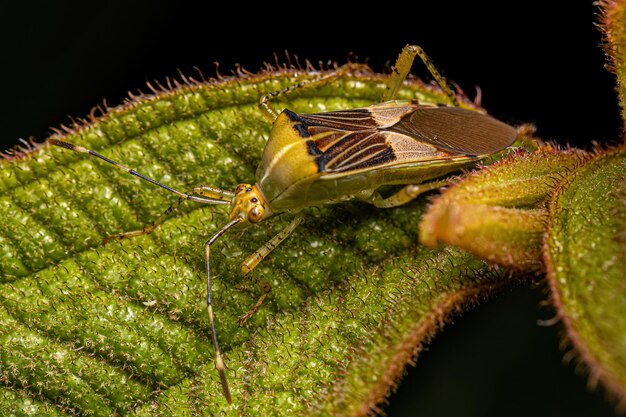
left=420, top=147, right=587, bottom=272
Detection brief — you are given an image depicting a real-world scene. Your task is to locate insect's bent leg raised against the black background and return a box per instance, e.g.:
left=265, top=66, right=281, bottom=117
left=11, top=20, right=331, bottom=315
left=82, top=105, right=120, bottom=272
left=383, top=45, right=459, bottom=107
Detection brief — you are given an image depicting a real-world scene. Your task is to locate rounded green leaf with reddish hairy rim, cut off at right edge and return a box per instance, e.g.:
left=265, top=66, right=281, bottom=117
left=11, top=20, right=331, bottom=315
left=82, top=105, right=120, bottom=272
left=545, top=146, right=626, bottom=407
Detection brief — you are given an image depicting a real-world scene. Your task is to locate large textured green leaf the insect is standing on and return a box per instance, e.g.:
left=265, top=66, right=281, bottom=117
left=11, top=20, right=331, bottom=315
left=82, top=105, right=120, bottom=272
left=0, top=67, right=515, bottom=416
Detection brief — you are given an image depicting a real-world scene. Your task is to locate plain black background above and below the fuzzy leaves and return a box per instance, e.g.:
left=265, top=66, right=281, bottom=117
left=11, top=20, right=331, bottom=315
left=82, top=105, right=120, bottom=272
left=0, top=0, right=620, bottom=416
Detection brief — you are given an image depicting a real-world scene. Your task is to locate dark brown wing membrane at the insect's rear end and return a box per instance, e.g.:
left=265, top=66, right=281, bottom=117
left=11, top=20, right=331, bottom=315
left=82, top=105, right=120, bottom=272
left=385, top=107, right=517, bottom=155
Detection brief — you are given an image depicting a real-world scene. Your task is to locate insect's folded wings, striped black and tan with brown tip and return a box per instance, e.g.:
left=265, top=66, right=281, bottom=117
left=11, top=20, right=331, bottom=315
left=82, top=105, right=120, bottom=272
left=297, top=103, right=516, bottom=174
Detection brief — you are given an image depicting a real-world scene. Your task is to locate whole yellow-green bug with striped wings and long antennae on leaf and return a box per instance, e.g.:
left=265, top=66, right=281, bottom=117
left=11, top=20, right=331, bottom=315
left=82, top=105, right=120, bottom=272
left=48, top=45, right=516, bottom=403
